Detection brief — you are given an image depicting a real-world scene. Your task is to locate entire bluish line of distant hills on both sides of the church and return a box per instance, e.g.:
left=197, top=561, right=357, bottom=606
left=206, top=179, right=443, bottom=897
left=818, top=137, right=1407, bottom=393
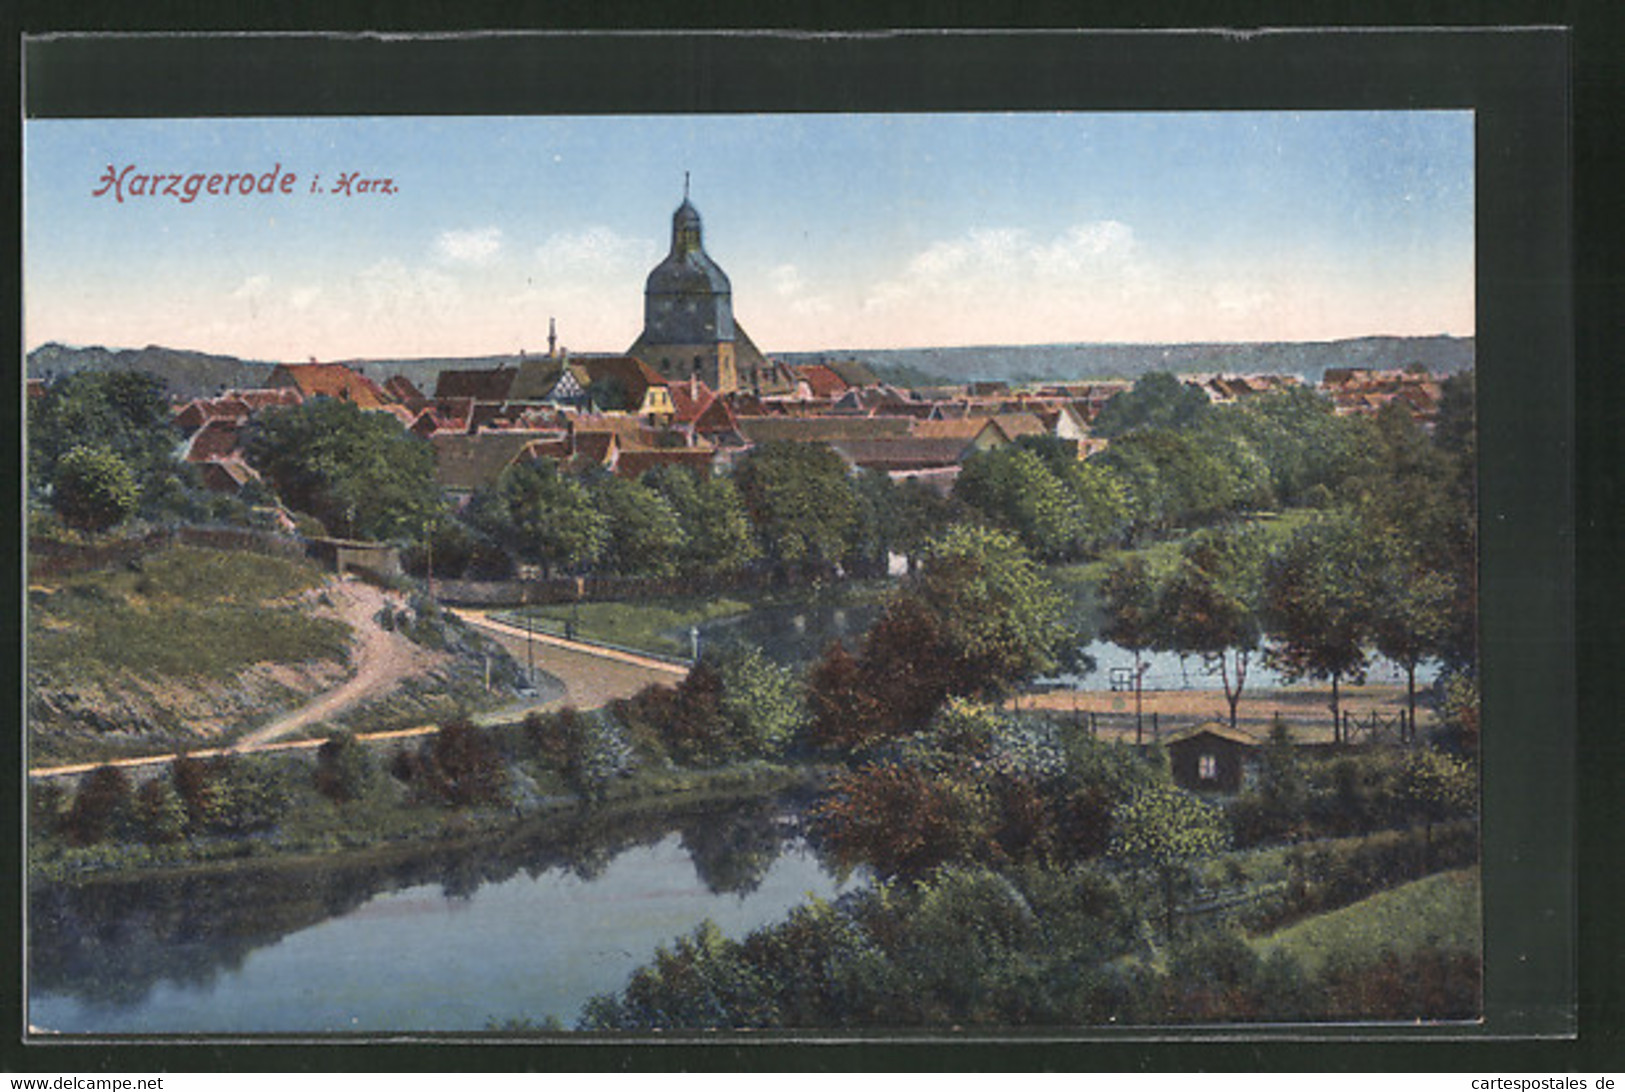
left=28, top=336, right=1474, bottom=398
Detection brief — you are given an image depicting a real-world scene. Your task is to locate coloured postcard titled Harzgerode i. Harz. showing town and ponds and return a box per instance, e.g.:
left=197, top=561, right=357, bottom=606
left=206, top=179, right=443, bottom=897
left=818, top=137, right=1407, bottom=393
left=23, top=29, right=1573, bottom=1042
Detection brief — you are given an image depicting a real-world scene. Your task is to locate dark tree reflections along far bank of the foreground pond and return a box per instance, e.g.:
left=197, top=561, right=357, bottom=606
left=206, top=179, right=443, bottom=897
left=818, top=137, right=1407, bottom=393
left=28, top=798, right=832, bottom=1008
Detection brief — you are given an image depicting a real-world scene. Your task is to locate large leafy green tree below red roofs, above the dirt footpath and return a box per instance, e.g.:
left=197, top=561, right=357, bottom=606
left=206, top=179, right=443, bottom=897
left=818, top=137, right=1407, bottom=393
left=242, top=398, right=444, bottom=541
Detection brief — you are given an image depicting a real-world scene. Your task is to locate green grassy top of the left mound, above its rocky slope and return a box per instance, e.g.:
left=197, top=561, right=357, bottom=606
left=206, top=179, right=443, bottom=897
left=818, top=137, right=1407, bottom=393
left=28, top=546, right=349, bottom=679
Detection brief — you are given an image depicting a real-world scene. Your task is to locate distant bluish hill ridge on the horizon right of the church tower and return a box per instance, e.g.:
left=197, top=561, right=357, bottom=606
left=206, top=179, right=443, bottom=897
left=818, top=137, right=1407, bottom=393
left=774, top=336, right=1474, bottom=387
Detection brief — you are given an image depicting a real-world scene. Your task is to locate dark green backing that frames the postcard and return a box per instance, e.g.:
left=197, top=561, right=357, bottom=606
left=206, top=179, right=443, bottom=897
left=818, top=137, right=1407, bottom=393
left=0, top=3, right=1605, bottom=1073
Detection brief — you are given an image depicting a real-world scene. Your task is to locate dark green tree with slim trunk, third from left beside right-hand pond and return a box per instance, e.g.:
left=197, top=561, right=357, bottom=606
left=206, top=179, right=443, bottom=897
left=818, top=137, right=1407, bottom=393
left=1263, top=515, right=1376, bottom=743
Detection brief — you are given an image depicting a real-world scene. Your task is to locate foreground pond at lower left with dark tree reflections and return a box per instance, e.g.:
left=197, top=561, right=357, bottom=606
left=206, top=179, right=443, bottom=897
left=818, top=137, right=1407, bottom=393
left=28, top=801, right=866, bottom=1035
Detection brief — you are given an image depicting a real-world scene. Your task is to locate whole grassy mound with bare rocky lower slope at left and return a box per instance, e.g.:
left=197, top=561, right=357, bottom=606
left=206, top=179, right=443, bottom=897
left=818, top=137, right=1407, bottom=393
left=26, top=546, right=351, bottom=764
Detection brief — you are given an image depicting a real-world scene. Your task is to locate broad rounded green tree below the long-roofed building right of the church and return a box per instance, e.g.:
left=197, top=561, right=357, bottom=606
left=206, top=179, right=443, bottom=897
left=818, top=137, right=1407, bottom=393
left=735, top=440, right=858, bottom=575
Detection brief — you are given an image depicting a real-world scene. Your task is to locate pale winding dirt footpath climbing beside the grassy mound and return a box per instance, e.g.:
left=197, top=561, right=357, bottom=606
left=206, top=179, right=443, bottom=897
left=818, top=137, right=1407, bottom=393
left=232, top=580, right=447, bottom=751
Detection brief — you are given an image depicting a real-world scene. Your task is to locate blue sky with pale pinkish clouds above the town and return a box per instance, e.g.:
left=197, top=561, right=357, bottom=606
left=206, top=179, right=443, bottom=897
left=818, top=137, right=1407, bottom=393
left=23, top=111, right=1474, bottom=361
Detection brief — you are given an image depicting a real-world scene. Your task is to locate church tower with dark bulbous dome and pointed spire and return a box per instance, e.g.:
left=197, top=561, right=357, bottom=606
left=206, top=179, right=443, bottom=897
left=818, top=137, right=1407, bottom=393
left=627, top=174, right=739, bottom=393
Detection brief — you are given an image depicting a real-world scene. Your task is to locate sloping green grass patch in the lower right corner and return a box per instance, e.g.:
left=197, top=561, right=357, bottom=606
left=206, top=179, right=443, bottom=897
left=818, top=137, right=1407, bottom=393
left=1253, top=868, right=1484, bottom=973
